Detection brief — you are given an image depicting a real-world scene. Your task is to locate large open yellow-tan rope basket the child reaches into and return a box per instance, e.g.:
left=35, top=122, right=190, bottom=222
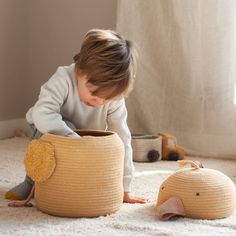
left=25, top=130, right=124, bottom=217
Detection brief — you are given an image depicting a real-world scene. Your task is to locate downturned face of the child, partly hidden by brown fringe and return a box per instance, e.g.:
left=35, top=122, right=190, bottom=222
left=78, top=76, right=108, bottom=107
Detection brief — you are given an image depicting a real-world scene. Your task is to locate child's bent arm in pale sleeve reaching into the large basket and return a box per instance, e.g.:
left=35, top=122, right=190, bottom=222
left=26, top=67, right=79, bottom=137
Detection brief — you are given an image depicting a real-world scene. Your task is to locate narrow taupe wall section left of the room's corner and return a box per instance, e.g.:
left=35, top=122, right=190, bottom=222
left=0, top=0, right=28, bottom=121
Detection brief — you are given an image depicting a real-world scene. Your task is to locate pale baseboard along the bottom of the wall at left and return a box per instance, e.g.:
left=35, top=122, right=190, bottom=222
left=0, top=118, right=29, bottom=139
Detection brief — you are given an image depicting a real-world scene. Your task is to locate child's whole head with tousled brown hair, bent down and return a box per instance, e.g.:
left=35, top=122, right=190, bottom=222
left=74, top=29, right=136, bottom=106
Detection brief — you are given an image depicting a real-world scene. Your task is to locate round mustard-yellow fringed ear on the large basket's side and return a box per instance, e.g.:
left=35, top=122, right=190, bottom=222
left=24, top=139, right=56, bottom=182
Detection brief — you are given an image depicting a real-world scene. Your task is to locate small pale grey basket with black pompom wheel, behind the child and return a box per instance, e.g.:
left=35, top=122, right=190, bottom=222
left=131, top=134, right=162, bottom=162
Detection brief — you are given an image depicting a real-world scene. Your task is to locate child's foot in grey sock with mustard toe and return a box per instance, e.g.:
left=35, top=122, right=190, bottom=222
left=5, top=175, right=34, bottom=200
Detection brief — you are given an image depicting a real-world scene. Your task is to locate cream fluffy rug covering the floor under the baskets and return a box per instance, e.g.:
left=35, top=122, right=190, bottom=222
left=0, top=138, right=236, bottom=236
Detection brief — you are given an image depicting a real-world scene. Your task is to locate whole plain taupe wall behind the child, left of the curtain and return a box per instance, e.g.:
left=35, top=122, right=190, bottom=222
left=0, top=0, right=117, bottom=121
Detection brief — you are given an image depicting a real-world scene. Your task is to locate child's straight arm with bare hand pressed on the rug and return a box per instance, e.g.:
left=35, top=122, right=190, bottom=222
left=107, top=99, right=147, bottom=203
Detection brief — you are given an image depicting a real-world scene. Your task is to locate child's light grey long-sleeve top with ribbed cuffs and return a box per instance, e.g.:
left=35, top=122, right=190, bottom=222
left=26, top=64, right=134, bottom=192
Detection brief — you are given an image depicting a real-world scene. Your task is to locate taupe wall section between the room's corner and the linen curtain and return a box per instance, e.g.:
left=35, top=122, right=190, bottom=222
left=27, top=0, right=116, bottom=110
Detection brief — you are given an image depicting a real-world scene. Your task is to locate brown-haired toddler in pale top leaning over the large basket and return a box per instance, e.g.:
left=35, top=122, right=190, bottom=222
left=5, top=29, right=147, bottom=203
